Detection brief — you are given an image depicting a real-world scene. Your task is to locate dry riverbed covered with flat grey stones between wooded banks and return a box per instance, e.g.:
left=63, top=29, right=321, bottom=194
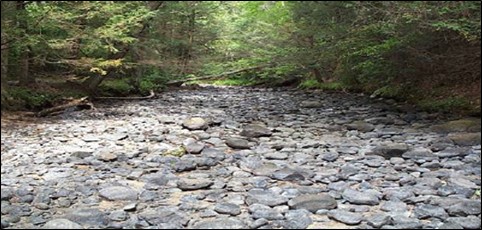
left=1, top=86, right=481, bottom=229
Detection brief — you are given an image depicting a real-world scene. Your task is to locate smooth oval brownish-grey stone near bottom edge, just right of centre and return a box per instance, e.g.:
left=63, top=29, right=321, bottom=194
left=288, top=194, right=337, bottom=213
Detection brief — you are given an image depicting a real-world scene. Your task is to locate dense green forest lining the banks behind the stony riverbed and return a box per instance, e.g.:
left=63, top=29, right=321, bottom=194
left=1, top=1, right=481, bottom=116
